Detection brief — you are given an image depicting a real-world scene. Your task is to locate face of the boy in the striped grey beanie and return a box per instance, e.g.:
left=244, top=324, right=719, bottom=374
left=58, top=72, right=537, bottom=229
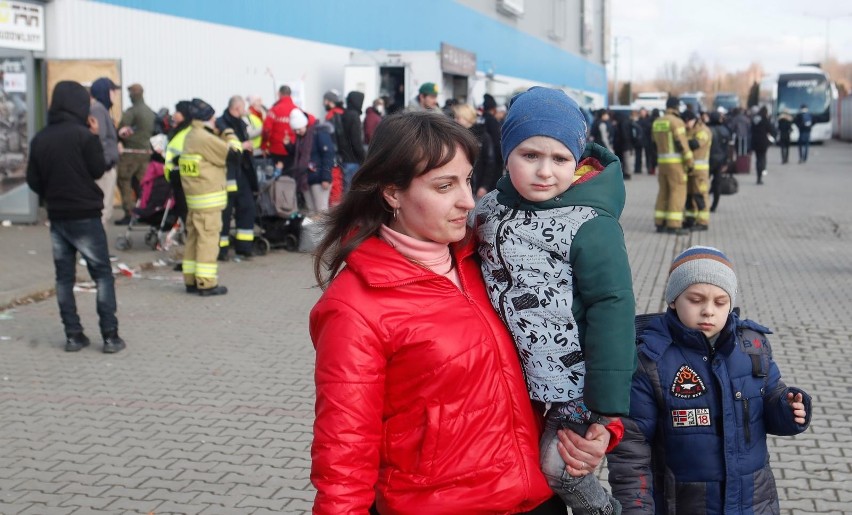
left=670, top=283, right=731, bottom=338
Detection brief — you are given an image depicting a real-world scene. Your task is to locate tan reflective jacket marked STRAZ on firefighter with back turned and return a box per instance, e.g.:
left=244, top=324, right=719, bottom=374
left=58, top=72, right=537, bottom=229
left=178, top=120, right=239, bottom=211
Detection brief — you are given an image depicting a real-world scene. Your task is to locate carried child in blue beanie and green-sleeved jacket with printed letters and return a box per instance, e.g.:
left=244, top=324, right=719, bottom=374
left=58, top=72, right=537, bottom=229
left=473, top=87, right=636, bottom=514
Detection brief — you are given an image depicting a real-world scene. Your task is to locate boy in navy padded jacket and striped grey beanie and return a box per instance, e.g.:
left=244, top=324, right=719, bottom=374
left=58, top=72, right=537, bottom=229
left=607, top=246, right=812, bottom=515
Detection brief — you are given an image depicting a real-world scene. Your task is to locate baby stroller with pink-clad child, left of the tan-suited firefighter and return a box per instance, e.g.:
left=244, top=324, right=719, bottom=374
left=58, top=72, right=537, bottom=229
left=115, top=160, right=183, bottom=251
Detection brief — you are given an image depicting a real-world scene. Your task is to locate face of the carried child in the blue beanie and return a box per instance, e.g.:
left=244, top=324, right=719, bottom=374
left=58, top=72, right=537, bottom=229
left=506, top=136, right=577, bottom=202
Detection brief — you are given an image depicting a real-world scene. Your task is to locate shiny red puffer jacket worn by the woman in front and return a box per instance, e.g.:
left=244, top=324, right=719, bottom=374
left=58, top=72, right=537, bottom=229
left=310, top=238, right=553, bottom=515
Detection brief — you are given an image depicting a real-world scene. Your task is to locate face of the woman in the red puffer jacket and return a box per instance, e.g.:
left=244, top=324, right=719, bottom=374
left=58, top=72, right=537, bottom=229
left=384, top=148, right=475, bottom=244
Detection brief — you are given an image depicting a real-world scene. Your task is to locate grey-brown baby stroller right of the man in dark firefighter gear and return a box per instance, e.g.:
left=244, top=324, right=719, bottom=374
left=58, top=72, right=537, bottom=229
left=254, top=169, right=305, bottom=255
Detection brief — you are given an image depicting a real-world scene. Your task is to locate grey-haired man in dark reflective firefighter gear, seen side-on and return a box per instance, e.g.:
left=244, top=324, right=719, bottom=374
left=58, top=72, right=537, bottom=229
left=216, top=96, right=258, bottom=261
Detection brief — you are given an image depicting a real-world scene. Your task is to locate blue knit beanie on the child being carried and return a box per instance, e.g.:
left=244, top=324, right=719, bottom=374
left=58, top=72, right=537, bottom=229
left=501, top=86, right=586, bottom=164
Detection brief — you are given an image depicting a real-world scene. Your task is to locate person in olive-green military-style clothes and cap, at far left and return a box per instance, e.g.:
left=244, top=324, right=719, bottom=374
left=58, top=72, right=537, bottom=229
left=115, top=84, right=157, bottom=225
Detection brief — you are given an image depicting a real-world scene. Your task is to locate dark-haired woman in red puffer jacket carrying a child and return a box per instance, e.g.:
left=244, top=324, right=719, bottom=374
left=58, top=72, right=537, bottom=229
left=310, top=113, right=607, bottom=515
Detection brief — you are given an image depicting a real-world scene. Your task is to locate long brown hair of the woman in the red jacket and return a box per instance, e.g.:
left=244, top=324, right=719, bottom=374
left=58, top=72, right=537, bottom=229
left=314, top=111, right=486, bottom=289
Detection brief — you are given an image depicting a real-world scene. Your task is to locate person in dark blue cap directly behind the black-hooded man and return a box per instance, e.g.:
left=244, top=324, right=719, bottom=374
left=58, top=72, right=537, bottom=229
left=89, top=77, right=121, bottom=228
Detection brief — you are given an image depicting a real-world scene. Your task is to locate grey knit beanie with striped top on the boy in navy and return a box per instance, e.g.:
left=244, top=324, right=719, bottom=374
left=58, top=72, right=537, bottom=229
left=666, top=245, right=737, bottom=309
